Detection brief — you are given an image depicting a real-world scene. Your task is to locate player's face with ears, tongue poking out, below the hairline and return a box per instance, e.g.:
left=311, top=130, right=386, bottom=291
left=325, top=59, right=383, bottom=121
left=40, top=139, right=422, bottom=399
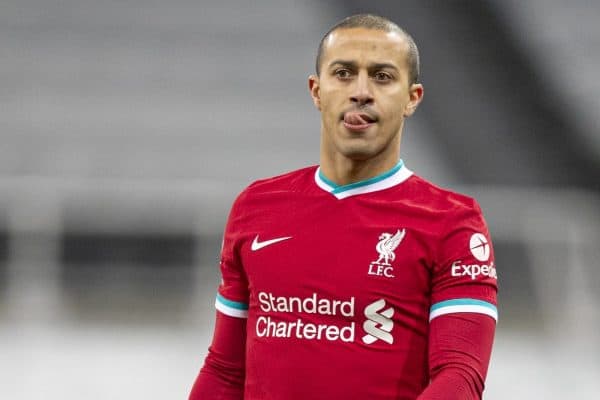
left=309, top=28, right=423, bottom=160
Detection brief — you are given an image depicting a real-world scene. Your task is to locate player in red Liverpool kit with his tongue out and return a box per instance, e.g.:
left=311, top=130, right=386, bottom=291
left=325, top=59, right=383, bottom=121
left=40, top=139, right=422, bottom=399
left=190, top=15, right=497, bottom=400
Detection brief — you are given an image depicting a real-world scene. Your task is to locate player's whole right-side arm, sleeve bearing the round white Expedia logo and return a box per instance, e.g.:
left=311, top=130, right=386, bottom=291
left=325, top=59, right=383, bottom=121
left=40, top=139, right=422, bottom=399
left=418, top=196, right=498, bottom=400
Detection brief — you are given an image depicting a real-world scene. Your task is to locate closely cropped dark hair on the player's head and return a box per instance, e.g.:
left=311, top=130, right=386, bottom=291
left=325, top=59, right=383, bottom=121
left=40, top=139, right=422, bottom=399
left=315, top=14, right=420, bottom=84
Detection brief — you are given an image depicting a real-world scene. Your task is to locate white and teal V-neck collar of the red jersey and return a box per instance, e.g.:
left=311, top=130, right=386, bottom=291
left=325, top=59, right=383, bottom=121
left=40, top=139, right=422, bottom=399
left=315, top=160, right=413, bottom=199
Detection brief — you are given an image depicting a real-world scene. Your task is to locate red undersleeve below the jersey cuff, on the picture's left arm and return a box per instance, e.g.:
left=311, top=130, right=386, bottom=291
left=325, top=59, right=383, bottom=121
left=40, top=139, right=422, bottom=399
left=189, top=311, right=246, bottom=400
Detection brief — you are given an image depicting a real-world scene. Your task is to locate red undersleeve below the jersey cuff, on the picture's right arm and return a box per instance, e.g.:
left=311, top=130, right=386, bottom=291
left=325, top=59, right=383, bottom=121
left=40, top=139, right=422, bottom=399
left=417, top=313, right=496, bottom=400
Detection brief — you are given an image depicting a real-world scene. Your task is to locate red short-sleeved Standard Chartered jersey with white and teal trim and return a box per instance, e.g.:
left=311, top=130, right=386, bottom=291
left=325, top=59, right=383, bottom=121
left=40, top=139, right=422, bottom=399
left=216, top=161, right=497, bottom=400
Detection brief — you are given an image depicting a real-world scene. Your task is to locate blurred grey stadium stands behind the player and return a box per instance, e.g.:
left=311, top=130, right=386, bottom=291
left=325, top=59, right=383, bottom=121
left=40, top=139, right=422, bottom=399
left=0, top=0, right=600, bottom=400
